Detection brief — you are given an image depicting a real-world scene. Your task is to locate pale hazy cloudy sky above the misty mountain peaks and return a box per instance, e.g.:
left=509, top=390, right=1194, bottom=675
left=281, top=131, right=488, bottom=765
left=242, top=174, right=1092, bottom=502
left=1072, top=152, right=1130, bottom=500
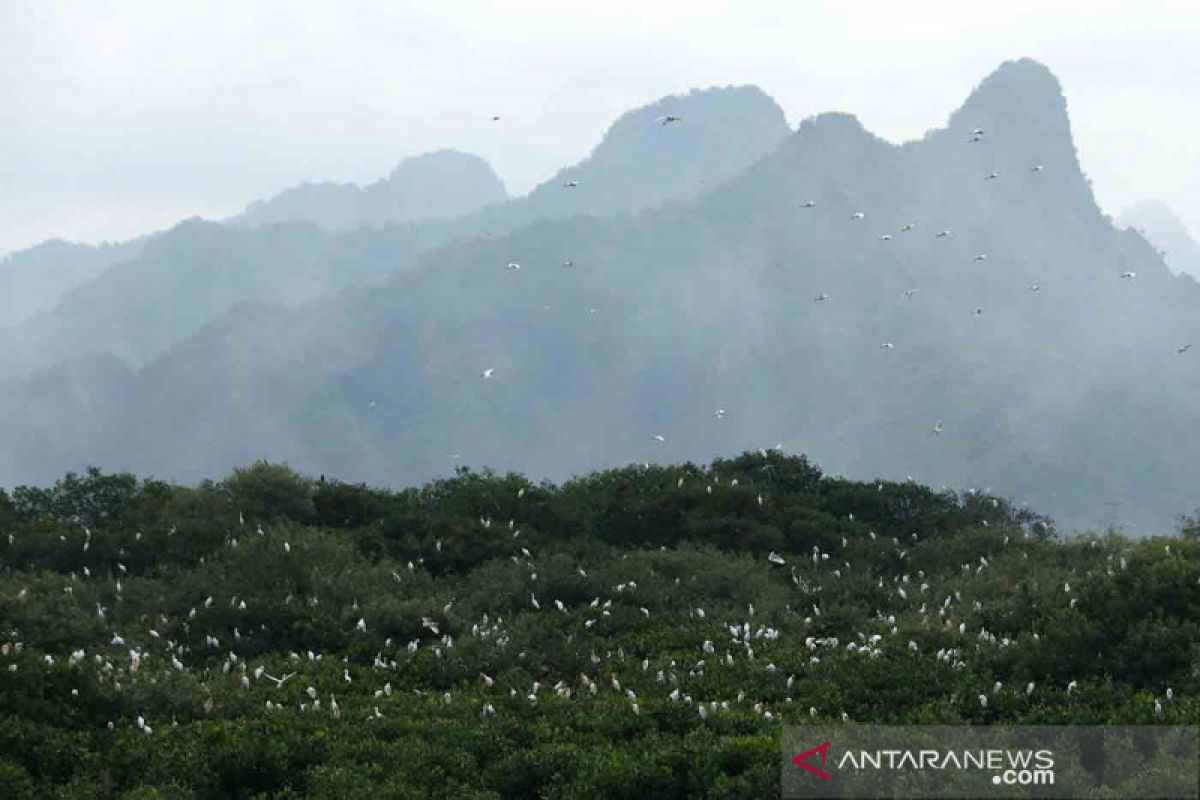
left=0, top=0, right=1200, bottom=253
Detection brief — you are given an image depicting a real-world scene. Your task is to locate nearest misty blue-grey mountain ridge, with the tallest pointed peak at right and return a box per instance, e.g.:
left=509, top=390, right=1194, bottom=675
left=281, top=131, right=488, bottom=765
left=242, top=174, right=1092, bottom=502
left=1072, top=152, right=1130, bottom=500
left=0, top=60, right=1200, bottom=533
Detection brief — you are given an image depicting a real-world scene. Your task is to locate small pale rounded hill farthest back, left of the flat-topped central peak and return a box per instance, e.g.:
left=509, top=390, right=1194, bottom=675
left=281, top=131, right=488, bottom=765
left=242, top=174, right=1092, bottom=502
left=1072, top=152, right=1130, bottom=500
left=233, top=150, right=509, bottom=230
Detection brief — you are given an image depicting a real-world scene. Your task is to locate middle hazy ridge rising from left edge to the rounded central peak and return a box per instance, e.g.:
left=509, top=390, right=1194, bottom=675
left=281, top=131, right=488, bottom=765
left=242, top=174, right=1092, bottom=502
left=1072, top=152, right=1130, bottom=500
left=0, top=88, right=787, bottom=380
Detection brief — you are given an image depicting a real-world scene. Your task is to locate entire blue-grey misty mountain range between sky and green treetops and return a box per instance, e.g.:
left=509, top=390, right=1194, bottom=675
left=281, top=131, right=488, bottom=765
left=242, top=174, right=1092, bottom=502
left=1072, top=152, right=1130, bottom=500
left=0, top=60, right=1200, bottom=535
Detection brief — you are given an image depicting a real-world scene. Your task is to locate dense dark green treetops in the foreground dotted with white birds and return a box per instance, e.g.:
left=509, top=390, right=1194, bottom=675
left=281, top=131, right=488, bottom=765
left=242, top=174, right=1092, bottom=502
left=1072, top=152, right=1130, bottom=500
left=0, top=451, right=1200, bottom=799
